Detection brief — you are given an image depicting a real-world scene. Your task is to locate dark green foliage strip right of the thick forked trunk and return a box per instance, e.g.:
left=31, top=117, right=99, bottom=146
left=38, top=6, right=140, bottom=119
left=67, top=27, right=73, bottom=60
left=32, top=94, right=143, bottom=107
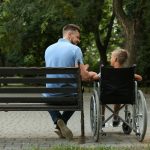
left=137, top=1, right=150, bottom=80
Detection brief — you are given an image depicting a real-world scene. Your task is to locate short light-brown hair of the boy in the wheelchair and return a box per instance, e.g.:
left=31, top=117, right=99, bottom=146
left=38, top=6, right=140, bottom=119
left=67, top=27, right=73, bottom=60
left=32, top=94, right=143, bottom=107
left=112, top=48, right=129, bottom=65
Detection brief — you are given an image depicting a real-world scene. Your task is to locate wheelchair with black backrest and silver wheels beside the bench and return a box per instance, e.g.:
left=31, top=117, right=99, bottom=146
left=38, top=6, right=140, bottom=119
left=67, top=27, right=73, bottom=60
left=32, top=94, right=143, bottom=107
left=90, top=66, right=148, bottom=142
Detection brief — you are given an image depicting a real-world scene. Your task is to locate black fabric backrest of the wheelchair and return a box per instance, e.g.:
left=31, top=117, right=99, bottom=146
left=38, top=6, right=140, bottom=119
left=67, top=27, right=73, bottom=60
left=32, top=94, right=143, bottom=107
left=100, top=66, right=135, bottom=104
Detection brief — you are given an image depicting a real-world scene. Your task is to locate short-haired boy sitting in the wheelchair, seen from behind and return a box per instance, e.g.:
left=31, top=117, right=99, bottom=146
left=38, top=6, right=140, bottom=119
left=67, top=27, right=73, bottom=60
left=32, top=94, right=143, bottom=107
left=90, top=49, right=142, bottom=127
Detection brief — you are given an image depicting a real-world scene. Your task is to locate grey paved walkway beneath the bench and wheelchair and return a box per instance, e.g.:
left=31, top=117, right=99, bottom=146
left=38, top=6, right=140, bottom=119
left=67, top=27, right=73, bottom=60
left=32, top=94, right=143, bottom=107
left=0, top=93, right=150, bottom=150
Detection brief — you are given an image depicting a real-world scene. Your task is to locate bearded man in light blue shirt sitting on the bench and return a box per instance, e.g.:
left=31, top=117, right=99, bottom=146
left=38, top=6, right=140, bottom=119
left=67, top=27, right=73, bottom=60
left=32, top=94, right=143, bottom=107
left=44, top=24, right=97, bottom=139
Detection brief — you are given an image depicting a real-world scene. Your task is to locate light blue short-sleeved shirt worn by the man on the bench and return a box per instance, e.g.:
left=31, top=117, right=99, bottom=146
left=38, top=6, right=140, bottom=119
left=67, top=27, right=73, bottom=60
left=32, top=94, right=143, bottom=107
left=44, top=38, right=83, bottom=96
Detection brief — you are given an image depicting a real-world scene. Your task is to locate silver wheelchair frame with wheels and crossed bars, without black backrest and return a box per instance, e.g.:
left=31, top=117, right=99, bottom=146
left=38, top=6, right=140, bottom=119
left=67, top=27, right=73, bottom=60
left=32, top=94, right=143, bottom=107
left=90, top=67, right=147, bottom=142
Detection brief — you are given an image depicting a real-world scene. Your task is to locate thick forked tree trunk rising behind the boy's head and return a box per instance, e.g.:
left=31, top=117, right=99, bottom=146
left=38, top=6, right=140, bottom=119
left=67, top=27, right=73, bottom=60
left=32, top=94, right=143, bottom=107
left=113, top=0, right=145, bottom=65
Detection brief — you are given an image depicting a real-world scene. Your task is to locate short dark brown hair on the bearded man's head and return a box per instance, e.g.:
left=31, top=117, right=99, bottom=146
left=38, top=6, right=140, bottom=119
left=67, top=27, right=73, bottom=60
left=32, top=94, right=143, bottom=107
left=63, top=24, right=80, bottom=35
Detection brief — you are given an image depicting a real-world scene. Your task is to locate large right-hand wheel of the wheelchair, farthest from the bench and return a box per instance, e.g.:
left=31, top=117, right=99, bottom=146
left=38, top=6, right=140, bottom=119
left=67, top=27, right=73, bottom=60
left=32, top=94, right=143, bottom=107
left=134, top=90, right=147, bottom=142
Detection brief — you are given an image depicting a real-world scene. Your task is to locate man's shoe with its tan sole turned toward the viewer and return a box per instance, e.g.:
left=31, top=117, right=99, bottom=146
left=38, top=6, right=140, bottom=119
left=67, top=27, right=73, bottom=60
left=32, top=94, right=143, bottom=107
left=57, top=119, right=73, bottom=140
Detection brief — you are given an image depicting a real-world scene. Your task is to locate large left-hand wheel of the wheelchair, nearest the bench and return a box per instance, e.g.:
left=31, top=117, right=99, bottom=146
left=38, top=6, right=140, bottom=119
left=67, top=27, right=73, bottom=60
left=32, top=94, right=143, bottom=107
left=90, top=90, right=100, bottom=142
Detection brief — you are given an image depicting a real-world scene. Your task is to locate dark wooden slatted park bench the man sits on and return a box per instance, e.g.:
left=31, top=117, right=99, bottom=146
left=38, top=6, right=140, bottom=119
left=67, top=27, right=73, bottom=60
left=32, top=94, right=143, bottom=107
left=0, top=67, right=84, bottom=137
